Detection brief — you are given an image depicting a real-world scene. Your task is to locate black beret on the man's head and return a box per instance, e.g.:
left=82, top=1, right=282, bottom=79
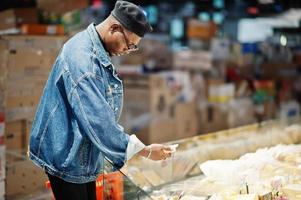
left=111, top=1, right=153, bottom=37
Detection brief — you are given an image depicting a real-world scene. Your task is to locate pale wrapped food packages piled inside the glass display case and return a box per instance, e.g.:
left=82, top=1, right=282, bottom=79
left=123, top=120, right=301, bottom=200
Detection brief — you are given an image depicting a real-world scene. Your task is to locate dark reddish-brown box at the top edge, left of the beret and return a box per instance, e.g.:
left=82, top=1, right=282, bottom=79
left=37, top=0, right=89, bottom=14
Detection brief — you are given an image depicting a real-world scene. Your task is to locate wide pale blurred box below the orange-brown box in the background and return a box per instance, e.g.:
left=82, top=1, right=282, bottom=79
left=173, top=50, right=212, bottom=70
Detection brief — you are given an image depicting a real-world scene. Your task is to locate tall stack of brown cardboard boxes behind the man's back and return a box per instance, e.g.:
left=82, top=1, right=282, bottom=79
left=0, top=36, right=65, bottom=151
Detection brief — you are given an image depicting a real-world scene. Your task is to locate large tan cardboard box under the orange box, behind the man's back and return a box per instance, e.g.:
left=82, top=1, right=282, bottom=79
left=2, top=36, right=64, bottom=81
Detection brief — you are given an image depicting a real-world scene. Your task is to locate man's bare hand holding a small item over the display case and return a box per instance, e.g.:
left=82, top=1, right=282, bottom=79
left=139, top=144, right=173, bottom=161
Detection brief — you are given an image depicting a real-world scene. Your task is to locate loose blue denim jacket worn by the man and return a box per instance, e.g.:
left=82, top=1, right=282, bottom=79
left=28, top=24, right=129, bottom=183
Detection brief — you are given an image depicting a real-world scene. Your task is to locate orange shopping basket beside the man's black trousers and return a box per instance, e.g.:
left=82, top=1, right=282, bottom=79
left=46, top=171, right=123, bottom=200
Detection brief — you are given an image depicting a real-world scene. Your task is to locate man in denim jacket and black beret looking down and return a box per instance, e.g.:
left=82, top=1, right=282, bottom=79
left=28, top=1, right=171, bottom=200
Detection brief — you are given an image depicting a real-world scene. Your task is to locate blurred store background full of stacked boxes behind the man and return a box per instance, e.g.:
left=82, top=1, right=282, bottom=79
left=0, top=0, right=301, bottom=199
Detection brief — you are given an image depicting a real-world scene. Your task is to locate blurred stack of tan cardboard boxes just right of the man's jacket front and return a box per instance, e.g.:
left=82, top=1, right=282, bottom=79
left=121, top=74, right=197, bottom=144
